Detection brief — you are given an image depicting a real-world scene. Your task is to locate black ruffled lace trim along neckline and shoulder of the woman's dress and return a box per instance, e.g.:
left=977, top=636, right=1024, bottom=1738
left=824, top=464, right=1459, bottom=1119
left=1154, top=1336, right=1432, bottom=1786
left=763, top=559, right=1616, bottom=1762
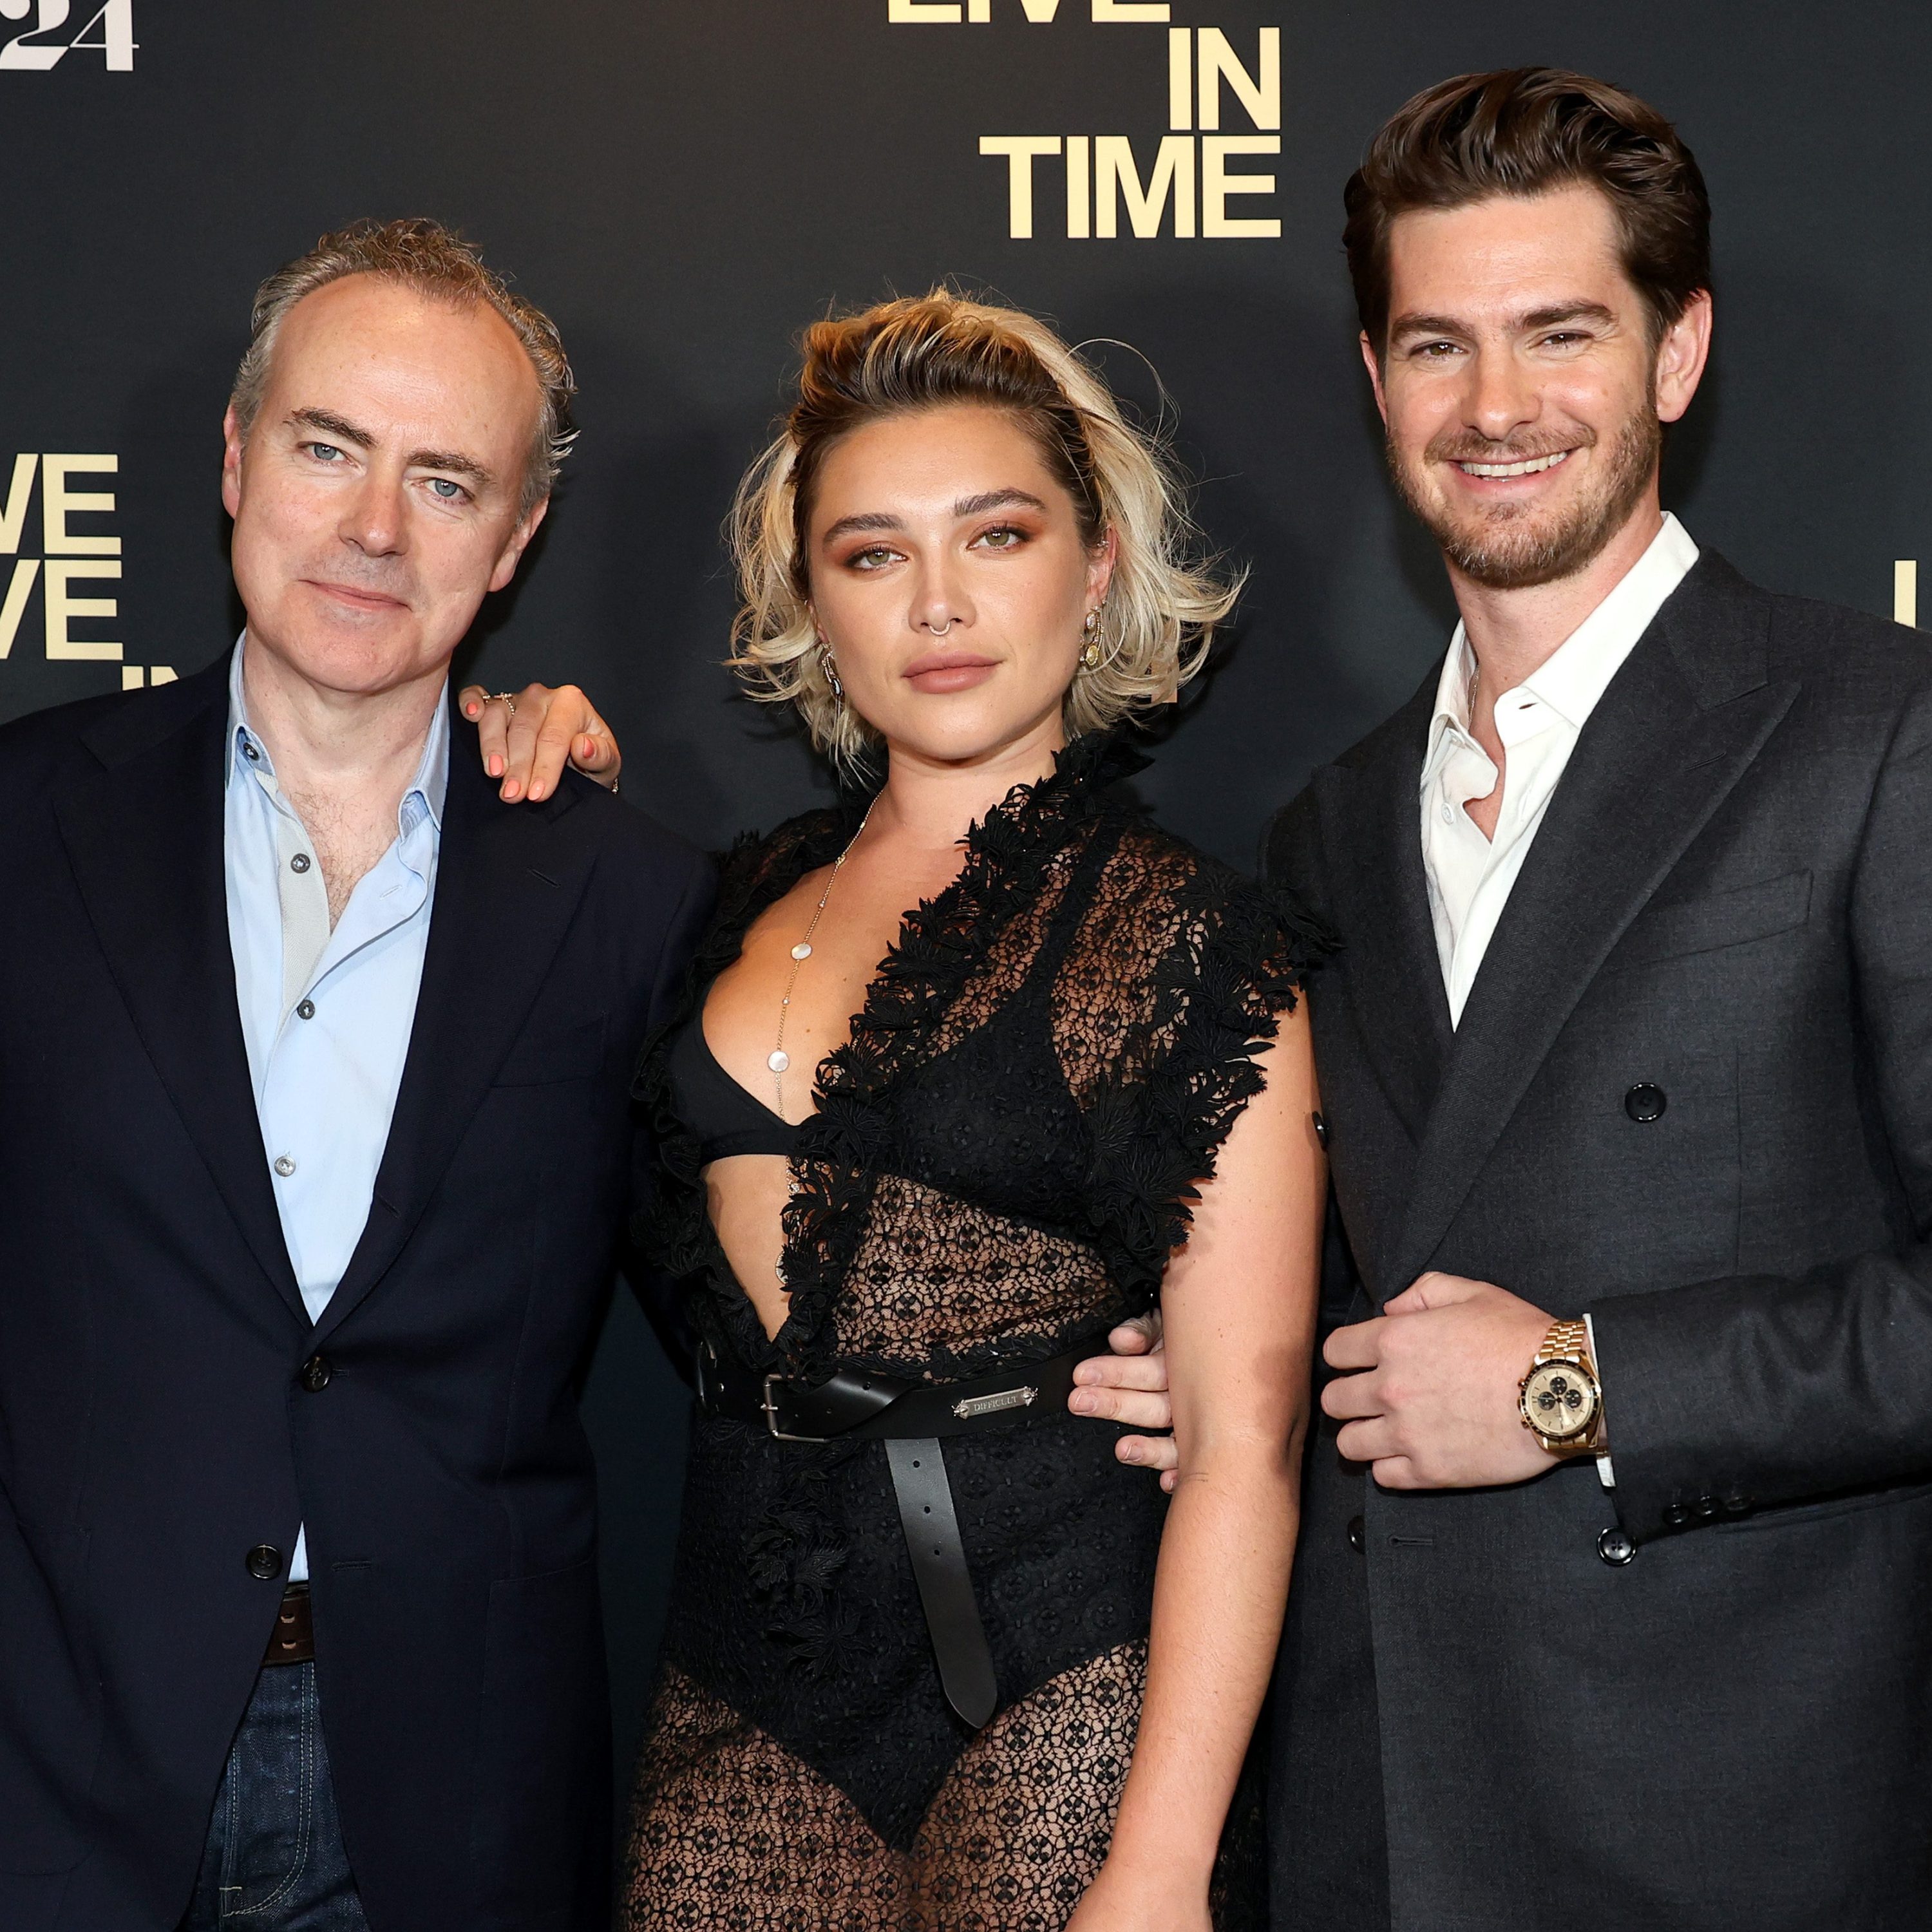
left=636, top=732, right=1329, bottom=1673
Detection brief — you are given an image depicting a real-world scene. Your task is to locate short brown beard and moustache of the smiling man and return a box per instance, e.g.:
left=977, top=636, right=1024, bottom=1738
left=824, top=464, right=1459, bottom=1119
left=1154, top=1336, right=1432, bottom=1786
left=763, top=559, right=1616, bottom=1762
left=1385, top=410, right=1663, bottom=591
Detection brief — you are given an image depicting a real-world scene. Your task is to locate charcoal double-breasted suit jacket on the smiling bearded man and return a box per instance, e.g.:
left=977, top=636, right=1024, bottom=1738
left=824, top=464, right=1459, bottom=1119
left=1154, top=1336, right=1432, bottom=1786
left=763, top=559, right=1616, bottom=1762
left=1269, top=553, right=1932, bottom=1932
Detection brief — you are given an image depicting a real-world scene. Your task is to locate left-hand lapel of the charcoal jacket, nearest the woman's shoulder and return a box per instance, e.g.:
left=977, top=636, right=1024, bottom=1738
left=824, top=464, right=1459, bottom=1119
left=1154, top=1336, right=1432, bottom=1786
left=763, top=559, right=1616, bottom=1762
left=1316, top=670, right=1453, bottom=1142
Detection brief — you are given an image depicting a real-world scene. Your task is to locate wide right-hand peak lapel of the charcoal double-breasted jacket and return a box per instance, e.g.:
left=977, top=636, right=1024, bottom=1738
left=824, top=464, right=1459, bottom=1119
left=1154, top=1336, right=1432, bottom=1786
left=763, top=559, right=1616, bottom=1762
left=1389, top=553, right=1797, bottom=1293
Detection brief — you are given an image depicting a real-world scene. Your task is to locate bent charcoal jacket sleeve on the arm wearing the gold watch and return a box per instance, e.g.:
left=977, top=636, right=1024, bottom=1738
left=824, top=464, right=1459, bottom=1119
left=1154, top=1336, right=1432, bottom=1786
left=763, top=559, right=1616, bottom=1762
left=1592, top=692, right=1932, bottom=1540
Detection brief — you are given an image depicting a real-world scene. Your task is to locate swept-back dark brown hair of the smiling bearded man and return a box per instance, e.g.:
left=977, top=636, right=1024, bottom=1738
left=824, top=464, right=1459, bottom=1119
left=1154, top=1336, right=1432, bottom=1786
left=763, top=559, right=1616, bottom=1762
left=1343, top=68, right=1710, bottom=355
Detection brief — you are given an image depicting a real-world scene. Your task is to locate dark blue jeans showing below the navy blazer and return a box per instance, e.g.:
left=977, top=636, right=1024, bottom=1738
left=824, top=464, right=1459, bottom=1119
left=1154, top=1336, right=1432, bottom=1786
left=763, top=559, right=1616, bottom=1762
left=180, top=1663, right=367, bottom=1932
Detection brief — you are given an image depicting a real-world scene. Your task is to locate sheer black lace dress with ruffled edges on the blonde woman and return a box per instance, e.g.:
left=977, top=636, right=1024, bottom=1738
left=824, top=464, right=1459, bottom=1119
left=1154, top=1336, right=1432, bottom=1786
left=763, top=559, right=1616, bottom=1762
left=626, top=736, right=1321, bottom=1932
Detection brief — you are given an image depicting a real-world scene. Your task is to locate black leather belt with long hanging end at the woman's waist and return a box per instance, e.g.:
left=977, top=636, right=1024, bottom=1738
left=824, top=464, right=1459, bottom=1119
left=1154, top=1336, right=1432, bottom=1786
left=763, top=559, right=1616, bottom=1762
left=697, top=1337, right=1105, bottom=1731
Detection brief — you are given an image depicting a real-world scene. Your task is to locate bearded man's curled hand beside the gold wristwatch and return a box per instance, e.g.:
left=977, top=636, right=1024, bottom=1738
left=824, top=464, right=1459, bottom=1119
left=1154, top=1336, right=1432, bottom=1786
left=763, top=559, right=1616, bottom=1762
left=1321, top=1275, right=1557, bottom=1490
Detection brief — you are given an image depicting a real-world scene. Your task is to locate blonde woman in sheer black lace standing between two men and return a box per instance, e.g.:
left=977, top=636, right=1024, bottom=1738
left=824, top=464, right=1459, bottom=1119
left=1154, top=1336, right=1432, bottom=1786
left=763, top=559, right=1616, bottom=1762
left=628, top=294, right=1323, bottom=1932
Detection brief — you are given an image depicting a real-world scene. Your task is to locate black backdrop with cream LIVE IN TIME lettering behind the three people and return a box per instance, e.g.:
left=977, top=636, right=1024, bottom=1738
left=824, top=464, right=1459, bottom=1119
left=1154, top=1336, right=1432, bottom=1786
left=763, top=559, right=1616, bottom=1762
left=0, top=0, right=1932, bottom=1777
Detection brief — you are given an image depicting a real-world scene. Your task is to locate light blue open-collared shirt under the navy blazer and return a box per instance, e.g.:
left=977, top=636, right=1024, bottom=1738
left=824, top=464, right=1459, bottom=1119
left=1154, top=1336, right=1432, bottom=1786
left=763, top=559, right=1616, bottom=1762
left=222, top=634, right=450, bottom=1582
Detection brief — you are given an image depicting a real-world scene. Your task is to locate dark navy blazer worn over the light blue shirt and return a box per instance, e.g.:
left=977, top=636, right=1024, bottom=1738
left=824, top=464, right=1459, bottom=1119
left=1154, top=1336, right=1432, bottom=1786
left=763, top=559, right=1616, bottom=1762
left=0, top=659, right=711, bottom=1932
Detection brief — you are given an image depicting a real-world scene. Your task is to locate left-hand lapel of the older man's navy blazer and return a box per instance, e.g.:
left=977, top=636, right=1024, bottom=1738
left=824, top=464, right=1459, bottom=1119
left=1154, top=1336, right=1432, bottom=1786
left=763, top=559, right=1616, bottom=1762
left=54, top=655, right=309, bottom=1325
